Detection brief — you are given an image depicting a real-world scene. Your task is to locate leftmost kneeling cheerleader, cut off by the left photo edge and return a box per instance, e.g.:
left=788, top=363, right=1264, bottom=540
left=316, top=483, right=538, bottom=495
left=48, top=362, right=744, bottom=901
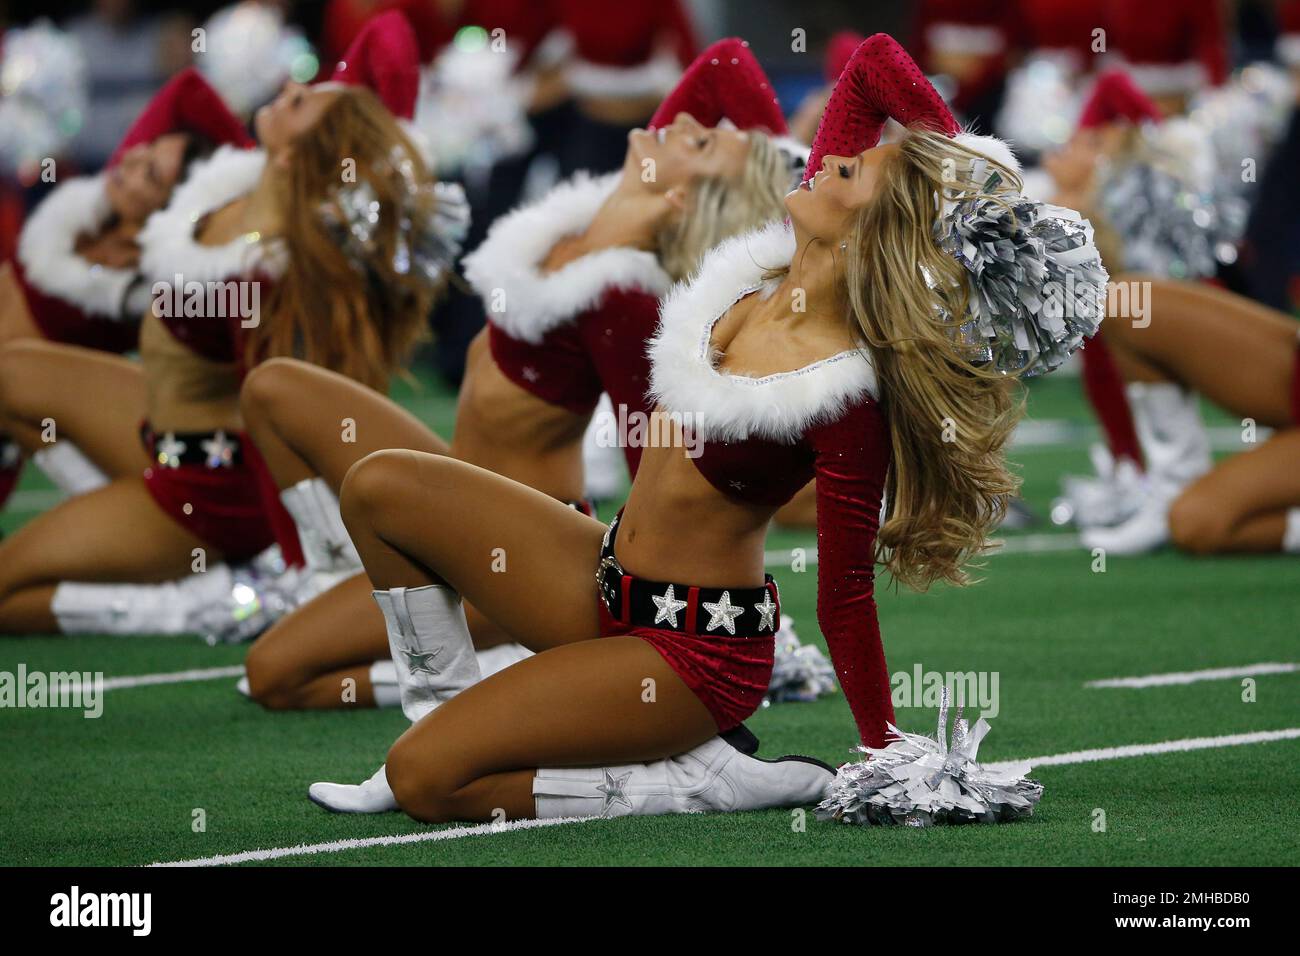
left=0, top=69, right=252, bottom=515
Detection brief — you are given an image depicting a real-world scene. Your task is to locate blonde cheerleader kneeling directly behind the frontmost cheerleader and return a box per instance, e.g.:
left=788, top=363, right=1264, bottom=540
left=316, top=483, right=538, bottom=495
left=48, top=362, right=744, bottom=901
left=242, top=39, right=802, bottom=709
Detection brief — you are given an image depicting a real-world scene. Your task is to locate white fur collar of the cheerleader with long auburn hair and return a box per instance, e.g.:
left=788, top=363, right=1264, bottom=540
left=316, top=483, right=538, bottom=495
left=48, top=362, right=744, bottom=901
left=139, top=146, right=285, bottom=282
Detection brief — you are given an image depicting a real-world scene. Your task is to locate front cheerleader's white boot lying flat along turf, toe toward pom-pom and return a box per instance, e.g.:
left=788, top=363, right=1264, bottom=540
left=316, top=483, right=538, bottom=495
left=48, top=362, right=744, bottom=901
left=533, top=737, right=835, bottom=819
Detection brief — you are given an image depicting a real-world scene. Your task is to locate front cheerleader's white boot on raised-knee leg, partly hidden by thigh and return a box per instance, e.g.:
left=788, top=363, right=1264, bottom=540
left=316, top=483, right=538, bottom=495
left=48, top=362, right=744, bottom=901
left=307, top=584, right=480, bottom=813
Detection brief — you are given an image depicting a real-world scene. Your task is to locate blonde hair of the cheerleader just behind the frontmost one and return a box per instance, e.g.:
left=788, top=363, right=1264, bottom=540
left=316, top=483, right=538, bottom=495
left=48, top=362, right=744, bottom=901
left=655, top=131, right=793, bottom=280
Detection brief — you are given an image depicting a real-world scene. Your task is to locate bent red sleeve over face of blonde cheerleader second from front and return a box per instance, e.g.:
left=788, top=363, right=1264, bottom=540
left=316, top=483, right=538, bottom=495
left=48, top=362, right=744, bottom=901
left=650, top=36, right=787, bottom=135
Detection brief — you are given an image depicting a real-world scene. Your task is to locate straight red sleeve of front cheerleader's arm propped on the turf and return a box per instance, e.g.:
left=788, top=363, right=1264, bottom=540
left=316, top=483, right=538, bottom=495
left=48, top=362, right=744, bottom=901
left=807, top=402, right=894, bottom=747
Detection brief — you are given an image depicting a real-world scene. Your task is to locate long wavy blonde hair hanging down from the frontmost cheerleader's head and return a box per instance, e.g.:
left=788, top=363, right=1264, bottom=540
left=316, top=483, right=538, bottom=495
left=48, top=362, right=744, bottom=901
left=845, top=129, right=1023, bottom=591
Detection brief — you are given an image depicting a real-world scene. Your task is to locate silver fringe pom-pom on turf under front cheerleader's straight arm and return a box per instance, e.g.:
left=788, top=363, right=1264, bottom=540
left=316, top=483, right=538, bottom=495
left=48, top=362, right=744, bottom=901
left=815, top=688, right=1043, bottom=826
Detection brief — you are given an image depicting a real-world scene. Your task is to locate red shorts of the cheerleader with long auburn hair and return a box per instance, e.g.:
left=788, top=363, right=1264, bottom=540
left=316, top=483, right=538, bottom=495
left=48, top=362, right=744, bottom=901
left=144, top=436, right=276, bottom=561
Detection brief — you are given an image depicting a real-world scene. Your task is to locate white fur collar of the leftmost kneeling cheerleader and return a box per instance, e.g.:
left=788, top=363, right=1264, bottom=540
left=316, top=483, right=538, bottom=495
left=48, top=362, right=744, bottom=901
left=18, top=174, right=139, bottom=319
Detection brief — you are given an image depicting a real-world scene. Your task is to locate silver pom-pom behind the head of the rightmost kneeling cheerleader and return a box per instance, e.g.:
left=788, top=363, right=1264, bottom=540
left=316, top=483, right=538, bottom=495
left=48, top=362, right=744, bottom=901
left=1097, top=163, right=1247, bottom=280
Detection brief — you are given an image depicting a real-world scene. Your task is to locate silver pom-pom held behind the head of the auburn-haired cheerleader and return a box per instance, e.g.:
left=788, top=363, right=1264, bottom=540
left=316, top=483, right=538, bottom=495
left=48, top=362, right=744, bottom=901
left=321, top=148, right=469, bottom=285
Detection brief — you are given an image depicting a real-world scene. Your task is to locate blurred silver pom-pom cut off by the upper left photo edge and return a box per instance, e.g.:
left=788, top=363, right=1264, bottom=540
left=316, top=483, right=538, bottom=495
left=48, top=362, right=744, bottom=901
left=0, top=20, right=87, bottom=179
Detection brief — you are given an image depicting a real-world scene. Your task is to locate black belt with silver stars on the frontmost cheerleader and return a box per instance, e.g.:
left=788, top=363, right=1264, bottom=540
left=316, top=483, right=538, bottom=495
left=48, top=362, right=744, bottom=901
left=595, top=512, right=781, bottom=637
